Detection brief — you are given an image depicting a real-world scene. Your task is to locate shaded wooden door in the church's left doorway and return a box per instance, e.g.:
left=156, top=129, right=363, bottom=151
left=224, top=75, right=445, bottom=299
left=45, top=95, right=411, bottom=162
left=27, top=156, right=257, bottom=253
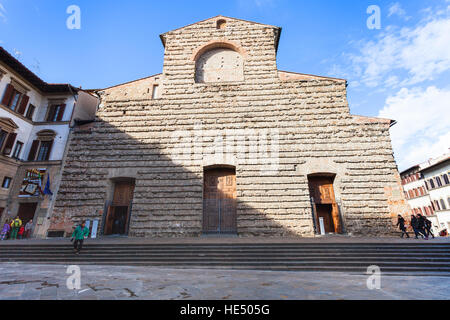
left=103, top=181, right=134, bottom=235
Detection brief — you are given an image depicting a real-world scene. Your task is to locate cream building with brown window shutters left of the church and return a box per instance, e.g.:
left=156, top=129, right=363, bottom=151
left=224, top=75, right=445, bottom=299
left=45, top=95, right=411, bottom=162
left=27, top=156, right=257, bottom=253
left=0, top=47, right=98, bottom=236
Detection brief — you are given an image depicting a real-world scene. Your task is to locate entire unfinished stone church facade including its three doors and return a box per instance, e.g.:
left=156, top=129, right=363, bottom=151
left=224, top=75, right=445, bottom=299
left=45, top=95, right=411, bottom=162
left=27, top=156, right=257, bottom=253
left=50, top=16, right=409, bottom=237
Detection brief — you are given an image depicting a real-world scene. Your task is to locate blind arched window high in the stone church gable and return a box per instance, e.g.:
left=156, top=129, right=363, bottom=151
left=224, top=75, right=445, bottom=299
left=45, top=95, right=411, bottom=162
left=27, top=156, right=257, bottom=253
left=195, top=47, right=244, bottom=83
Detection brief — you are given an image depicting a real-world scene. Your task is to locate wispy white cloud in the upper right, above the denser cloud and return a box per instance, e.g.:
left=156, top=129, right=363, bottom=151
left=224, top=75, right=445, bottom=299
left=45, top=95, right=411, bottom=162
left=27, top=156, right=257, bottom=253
left=349, top=15, right=450, bottom=87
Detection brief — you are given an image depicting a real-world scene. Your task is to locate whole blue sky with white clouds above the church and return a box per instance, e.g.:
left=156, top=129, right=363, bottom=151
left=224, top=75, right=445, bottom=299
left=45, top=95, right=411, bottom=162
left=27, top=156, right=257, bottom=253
left=0, top=0, right=450, bottom=170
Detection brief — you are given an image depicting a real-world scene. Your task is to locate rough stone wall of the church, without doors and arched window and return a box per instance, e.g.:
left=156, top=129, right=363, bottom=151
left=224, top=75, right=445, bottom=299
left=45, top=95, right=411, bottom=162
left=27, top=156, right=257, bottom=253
left=50, top=19, right=402, bottom=236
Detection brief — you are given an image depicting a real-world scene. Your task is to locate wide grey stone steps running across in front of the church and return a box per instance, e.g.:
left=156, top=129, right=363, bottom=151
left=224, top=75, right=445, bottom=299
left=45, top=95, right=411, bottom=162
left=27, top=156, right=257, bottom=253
left=0, top=240, right=450, bottom=274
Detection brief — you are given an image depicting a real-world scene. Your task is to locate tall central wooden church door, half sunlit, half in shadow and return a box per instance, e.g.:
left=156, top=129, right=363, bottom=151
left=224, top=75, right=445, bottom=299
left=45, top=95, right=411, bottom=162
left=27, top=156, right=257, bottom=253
left=203, top=168, right=237, bottom=233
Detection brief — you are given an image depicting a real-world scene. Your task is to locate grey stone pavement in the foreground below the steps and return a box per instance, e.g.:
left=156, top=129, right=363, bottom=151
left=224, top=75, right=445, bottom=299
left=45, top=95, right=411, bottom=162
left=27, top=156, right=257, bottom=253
left=0, top=263, right=450, bottom=300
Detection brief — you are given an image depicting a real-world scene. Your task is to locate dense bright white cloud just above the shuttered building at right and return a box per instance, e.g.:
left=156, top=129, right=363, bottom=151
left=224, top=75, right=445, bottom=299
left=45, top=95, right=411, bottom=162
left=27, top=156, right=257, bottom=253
left=378, top=86, right=450, bottom=170
